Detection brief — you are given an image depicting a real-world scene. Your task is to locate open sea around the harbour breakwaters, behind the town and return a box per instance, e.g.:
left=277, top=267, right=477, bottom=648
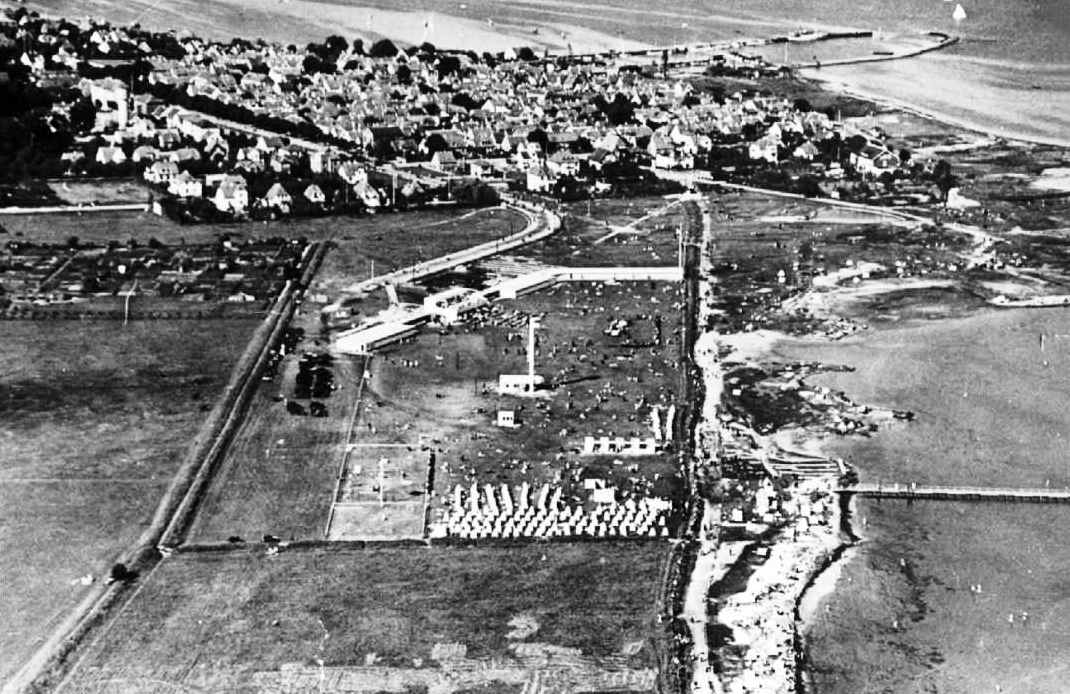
left=460, top=0, right=1070, bottom=143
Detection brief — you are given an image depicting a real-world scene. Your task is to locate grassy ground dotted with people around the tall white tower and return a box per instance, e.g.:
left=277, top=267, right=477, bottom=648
left=355, top=282, right=681, bottom=513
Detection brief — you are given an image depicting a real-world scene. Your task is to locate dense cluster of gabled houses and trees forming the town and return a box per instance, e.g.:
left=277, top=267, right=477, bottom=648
left=6, top=6, right=920, bottom=214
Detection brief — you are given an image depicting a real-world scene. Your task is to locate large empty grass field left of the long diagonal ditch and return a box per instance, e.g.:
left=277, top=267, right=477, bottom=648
left=0, top=321, right=256, bottom=680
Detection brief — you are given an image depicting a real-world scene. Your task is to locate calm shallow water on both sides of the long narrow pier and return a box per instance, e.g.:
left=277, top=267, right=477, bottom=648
left=777, top=309, right=1070, bottom=694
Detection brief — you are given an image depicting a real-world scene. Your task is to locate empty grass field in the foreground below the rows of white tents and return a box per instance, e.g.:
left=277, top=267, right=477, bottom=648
left=59, top=543, right=668, bottom=693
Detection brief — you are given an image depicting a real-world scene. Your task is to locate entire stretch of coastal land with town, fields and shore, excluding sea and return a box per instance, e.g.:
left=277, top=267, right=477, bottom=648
left=6, top=4, right=1070, bottom=694
